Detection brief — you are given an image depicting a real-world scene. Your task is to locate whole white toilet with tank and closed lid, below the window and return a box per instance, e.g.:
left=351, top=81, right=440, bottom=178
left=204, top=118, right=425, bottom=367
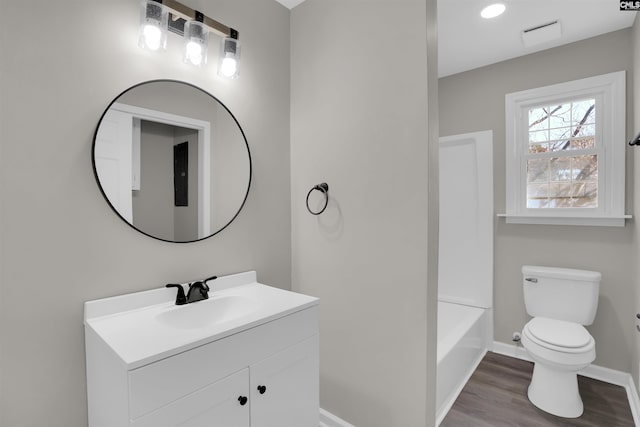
left=522, top=265, right=602, bottom=418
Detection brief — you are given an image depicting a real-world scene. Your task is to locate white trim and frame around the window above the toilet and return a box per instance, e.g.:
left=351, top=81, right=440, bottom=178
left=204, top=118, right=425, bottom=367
left=500, top=71, right=630, bottom=226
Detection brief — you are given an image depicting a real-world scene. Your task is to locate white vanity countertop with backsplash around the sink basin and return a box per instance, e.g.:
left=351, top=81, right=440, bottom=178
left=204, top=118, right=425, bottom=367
left=84, top=272, right=319, bottom=369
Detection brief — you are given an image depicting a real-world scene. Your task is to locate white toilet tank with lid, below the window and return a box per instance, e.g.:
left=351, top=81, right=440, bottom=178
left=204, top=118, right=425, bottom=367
left=522, top=265, right=602, bottom=325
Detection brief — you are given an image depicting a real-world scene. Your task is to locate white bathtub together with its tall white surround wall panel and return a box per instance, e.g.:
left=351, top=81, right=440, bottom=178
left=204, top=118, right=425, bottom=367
left=436, top=131, right=494, bottom=424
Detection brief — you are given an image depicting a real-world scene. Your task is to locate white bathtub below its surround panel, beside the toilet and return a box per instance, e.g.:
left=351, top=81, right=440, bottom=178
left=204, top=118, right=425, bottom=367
left=436, top=301, right=492, bottom=425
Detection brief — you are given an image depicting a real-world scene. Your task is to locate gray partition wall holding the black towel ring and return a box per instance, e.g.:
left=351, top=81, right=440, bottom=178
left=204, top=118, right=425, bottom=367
left=291, top=0, right=437, bottom=427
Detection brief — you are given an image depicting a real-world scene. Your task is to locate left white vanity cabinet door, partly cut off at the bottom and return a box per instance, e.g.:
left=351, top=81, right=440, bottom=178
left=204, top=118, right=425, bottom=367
left=131, top=369, right=250, bottom=427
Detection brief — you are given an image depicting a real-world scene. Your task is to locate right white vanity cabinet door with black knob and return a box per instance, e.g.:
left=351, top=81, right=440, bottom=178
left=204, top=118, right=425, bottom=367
left=250, top=335, right=320, bottom=427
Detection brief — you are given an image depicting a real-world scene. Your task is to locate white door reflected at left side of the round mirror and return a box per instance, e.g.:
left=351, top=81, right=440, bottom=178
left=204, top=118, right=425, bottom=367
left=94, top=109, right=133, bottom=224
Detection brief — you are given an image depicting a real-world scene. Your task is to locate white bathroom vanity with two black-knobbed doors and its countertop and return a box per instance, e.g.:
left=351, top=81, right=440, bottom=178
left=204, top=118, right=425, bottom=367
left=85, top=274, right=319, bottom=427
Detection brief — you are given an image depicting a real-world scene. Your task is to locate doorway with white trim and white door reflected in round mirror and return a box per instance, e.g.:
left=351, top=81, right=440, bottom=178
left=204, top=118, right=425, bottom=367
left=96, top=103, right=212, bottom=241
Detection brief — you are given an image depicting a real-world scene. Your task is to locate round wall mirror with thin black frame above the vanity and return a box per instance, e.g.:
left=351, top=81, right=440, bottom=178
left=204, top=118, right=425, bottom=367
left=93, top=80, right=251, bottom=242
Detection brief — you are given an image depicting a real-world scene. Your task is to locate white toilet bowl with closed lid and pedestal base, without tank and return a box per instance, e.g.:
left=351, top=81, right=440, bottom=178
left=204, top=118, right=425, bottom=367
left=522, top=317, right=596, bottom=418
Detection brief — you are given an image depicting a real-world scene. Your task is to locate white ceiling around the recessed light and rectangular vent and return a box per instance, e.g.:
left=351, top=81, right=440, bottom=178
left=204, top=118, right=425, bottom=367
left=277, top=0, right=636, bottom=77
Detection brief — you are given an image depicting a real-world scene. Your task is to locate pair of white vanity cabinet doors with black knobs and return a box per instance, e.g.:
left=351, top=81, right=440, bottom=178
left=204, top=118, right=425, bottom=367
left=131, top=335, right=319, bottom=427
